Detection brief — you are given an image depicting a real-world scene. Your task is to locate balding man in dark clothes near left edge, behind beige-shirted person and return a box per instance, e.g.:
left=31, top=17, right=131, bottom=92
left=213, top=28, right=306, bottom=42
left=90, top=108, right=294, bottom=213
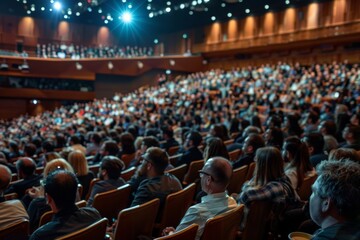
left=5, top=157, right=41, bottom=199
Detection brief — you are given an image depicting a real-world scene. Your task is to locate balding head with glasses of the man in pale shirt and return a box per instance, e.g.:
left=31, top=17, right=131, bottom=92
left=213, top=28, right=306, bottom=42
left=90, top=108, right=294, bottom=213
left=199, top=157, right=232, bottom=194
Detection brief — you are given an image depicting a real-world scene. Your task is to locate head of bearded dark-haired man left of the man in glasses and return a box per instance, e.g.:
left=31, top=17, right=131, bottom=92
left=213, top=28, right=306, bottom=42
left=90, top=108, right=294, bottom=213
left=142, top=147, right=169, bottom=178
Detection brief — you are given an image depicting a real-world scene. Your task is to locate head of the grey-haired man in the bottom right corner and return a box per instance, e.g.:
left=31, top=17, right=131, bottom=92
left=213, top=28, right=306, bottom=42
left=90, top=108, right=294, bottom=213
left=310, top=160, right=360, bottom=228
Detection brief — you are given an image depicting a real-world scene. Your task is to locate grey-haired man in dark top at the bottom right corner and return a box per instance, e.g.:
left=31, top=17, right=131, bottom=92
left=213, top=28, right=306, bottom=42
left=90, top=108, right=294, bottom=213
left=310, top=160, right=360, bottom=240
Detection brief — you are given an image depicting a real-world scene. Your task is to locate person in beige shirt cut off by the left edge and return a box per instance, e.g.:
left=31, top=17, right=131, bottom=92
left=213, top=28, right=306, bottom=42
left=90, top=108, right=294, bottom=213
left=0, top=165, right=29, bottom=229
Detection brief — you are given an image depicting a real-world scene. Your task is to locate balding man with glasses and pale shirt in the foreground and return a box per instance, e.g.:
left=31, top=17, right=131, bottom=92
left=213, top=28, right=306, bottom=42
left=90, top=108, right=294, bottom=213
left=164, top=157, right=236, bottom=239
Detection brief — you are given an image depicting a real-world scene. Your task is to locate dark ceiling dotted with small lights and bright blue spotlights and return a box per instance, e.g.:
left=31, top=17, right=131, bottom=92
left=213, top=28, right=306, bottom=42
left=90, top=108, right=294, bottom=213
left=0, top=0, right=330, bottom=33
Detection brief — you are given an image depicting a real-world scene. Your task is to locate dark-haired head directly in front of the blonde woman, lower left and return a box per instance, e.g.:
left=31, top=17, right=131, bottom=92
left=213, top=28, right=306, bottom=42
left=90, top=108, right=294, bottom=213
left=43, top=170, right=78, bottom=213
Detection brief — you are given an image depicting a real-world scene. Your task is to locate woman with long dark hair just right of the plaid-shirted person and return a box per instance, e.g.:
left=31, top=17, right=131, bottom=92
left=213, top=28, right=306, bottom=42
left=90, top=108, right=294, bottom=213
left=283, top=137, right=316, bottom=190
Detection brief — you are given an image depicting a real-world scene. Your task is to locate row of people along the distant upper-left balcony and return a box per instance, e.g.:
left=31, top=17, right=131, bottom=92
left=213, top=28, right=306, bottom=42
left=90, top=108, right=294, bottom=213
left=35, top=43, right=154, bottom=59
